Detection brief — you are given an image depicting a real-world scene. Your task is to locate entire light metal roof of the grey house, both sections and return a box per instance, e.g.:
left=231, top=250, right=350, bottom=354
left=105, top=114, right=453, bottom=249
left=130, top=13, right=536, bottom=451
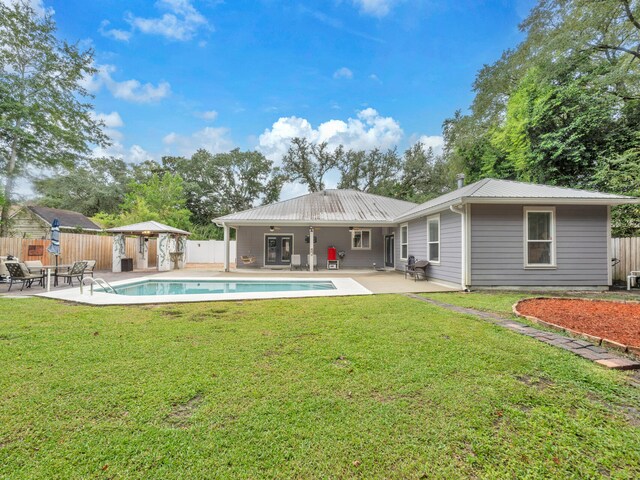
left=215, top=178, right=640, bottom=226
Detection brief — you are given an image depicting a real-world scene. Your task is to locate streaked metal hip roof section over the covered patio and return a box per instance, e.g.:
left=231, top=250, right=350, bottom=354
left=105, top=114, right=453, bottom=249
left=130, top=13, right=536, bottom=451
left=216, top=189, right=416, bottom=226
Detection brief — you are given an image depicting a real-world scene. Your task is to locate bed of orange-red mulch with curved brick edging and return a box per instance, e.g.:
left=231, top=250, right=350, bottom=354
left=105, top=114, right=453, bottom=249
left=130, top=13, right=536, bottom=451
left=518, top=298, right=640, bottom=347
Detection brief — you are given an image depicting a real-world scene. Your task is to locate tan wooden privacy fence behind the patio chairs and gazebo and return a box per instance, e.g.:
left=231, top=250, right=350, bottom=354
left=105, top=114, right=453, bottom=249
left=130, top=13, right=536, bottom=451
left=0, top=233, right=157, bottom=270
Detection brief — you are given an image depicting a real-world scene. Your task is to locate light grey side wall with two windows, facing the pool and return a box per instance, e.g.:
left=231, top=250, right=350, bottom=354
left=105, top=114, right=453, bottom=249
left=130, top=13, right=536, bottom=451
left=395, top=210, right=462, bottom=285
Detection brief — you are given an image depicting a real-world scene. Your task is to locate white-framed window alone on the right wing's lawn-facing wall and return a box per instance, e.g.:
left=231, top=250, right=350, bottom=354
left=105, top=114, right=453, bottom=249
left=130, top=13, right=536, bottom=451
left=524, top=207, right=556, bottom=267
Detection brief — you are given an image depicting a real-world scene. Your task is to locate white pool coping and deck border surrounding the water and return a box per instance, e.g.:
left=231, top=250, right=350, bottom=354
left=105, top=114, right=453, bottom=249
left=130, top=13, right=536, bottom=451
left=36, top=275, right=373, bottom=306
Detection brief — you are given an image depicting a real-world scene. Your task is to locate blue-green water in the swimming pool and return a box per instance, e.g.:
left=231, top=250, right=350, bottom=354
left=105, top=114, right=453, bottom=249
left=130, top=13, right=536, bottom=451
left=107, top=280, right=336, bottom=296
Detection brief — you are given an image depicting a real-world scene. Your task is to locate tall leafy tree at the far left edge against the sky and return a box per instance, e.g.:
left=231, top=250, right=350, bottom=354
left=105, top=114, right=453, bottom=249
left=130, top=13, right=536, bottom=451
left=0, top=2, right=107, bottom=236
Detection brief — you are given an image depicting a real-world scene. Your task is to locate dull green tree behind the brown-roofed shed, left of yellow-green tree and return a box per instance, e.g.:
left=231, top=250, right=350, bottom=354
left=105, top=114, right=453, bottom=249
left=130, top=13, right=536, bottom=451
left=34, top=158, right=133, bottom=217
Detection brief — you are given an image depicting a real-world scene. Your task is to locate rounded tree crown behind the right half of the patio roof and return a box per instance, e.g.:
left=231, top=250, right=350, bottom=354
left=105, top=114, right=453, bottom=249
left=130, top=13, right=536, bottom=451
left=337, top=148, right=402, bottom=195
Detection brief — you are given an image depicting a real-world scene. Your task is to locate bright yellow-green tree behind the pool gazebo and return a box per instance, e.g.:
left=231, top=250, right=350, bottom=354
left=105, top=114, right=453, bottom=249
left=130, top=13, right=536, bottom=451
left=94, top=173, right=191, bottom=230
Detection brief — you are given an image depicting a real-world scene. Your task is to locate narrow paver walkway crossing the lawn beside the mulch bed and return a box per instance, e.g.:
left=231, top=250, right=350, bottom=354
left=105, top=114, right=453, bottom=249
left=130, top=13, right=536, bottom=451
left=406, top=293, right=640, bottom=370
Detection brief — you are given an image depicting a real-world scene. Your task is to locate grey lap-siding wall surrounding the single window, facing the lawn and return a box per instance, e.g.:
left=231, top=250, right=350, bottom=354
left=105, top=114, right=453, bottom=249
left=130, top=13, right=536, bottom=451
left=471, top=205, right=610, bottom=287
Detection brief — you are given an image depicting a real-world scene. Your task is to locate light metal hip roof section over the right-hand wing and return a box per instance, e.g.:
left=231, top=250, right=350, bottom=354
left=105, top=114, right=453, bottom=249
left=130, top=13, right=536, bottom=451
left=396, top=178, right=640, bottom=222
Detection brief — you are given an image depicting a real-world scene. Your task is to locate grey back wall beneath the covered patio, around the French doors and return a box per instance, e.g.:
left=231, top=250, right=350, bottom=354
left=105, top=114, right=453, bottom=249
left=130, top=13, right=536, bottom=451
left=231, top=226, right=384, bottom=269
